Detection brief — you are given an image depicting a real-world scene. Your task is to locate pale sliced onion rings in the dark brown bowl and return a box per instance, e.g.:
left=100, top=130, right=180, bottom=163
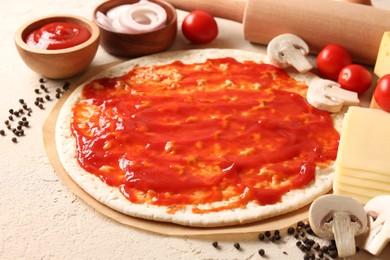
left=96, top=0, right=167, bottom=34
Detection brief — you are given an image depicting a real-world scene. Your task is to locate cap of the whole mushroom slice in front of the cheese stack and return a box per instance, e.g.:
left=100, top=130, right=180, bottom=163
left=309, top=194, right=367, bottom=239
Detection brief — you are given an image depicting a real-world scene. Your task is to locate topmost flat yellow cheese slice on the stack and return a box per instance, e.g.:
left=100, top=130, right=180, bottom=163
left=336, top=107, right=390, bottom=176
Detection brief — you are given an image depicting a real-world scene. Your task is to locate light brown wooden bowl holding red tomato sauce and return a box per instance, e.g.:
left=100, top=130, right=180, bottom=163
left=15, top=15, right=100, bottom=79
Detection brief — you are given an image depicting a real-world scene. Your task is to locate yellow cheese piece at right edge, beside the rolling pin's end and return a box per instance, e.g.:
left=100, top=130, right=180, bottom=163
left=374, top=32, right=390, bottom=78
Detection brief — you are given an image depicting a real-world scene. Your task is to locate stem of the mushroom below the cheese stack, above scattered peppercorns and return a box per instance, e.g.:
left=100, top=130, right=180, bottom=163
left=332, top=211, right=359, bottom=257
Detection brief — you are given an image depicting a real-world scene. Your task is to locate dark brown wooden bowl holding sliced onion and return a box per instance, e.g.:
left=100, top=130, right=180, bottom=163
left=93, top=0, right=177, bottom=57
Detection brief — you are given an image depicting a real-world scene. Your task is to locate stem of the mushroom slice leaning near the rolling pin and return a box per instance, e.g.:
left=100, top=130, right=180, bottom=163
left=280, top=42, right=313, bottom=73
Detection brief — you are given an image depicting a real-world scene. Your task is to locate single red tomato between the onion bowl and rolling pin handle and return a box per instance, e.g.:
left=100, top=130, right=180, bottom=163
left=181, top=11, right=218, bottom=44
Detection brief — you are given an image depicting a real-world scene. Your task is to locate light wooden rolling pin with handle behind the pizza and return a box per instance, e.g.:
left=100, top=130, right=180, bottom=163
left=167, top=0, right=390, bottom=65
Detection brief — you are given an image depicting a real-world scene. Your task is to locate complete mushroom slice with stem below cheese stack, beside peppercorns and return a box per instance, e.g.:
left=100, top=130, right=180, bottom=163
left=309, top=194, right=367, bottom=257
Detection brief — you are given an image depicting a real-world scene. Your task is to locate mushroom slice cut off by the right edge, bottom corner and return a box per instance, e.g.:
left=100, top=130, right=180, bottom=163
left=363, top=195, right=390, bottom=255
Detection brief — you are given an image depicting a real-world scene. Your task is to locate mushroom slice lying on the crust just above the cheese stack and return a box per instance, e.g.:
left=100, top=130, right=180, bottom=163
left=306, top=78, right=360, bottom=113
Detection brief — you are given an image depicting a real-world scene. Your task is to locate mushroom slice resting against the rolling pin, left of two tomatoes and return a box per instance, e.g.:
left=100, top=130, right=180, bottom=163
left=267, top=33, right=313, bottom=73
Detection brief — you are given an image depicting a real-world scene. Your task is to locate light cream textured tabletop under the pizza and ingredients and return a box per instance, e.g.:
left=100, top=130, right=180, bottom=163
left=0, top=0, right=390, bottom=259
